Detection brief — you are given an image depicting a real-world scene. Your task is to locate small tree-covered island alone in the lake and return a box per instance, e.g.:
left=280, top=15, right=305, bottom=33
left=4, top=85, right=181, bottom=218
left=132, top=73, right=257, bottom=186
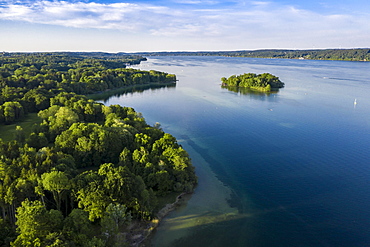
left=221, top=73, right=284, bottom=92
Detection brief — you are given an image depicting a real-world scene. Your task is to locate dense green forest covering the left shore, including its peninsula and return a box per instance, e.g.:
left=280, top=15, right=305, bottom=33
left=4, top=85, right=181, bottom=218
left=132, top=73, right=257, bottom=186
left=0, top=53, right=197, bottom=246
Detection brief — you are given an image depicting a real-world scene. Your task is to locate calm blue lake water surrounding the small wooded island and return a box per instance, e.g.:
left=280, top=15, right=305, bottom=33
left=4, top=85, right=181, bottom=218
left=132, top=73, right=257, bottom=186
left=98, top=57, right=370, bottom=247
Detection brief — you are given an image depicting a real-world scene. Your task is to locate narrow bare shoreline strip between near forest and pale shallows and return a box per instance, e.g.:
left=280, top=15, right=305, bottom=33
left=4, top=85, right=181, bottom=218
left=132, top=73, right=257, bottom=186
left=123, top=192, right=192, bottom=247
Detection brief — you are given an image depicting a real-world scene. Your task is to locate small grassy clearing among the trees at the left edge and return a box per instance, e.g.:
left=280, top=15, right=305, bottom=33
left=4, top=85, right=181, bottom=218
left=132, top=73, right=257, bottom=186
left=0, top=113, right=41, bottom=141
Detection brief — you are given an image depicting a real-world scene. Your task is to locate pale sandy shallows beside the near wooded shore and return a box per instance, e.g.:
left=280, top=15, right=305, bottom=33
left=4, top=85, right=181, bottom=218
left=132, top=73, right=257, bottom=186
left=151, top=140, right=240, bottom=247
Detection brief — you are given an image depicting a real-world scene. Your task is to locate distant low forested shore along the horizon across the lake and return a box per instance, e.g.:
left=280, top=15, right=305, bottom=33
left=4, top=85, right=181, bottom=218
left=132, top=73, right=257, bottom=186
left=136, top=49, right=370, bottom=61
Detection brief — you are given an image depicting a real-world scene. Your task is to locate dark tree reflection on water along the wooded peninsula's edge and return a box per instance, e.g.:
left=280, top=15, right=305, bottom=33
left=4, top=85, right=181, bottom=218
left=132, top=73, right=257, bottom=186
left=89, top=82, right=176, bottom=103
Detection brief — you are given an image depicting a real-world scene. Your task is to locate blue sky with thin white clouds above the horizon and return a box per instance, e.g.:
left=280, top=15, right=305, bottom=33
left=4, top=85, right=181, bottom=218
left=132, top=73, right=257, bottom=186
left=0, top=0, right=370, bottom=52
